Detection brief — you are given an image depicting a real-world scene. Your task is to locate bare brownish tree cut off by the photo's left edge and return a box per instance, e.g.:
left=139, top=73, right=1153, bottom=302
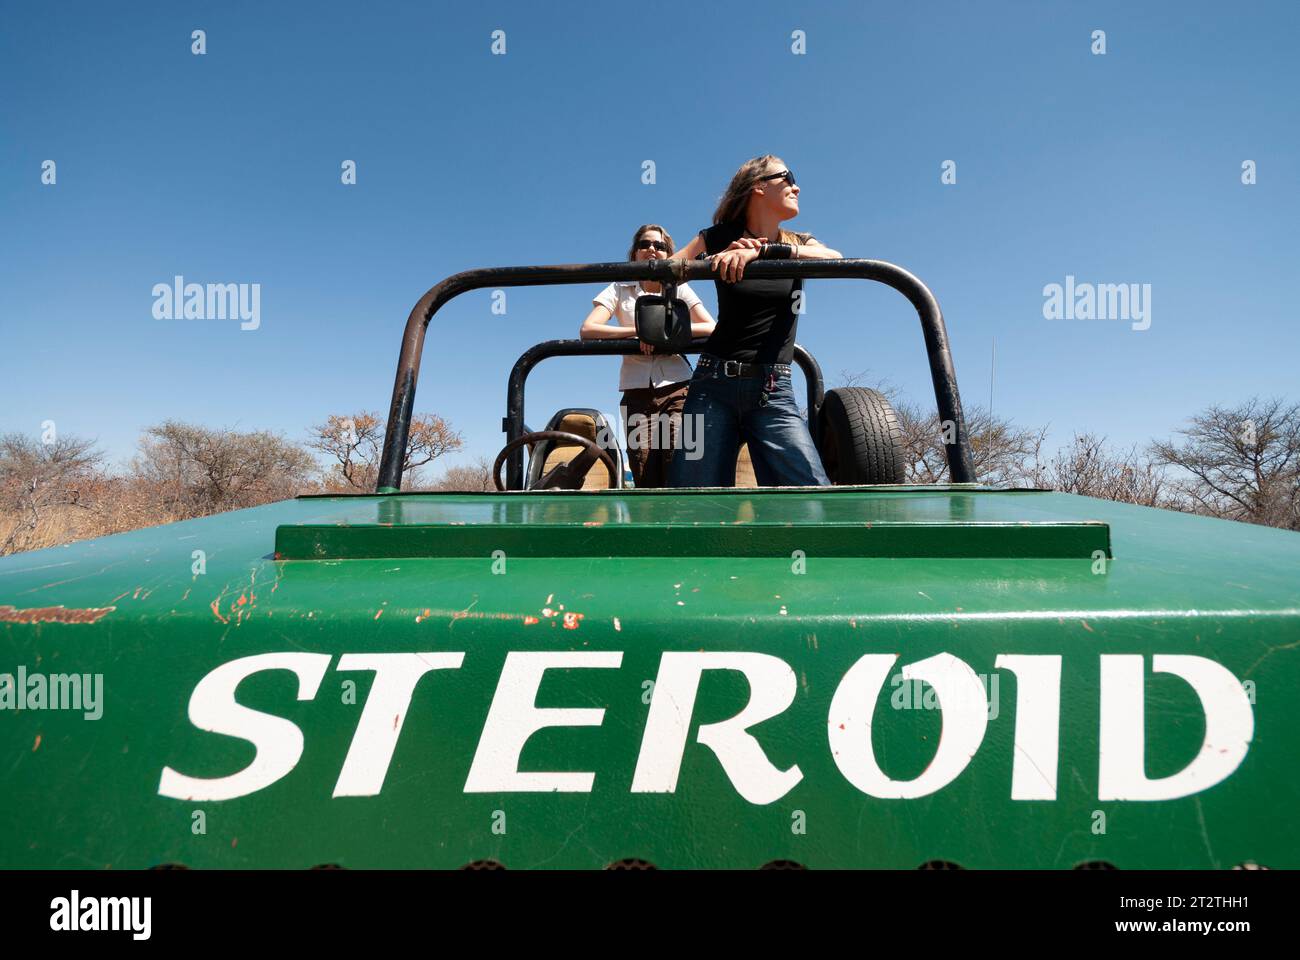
left=0, top=433, right=103, bottom=557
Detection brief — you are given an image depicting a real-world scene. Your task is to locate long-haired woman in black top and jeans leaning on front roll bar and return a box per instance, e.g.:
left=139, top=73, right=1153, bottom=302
left=670, top=153, right=840, bottom=487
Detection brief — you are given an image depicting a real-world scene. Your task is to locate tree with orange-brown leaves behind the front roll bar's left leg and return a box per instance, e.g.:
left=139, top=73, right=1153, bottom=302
left=307, top=410, right=464, bottom=490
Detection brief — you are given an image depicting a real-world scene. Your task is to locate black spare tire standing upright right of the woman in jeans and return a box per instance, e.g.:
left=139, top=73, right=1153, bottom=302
left=818, top=386, right=905, bottom=485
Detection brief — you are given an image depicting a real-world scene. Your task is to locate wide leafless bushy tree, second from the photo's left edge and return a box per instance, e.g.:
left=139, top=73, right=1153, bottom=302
left=131, top=420, right=317, bottom=519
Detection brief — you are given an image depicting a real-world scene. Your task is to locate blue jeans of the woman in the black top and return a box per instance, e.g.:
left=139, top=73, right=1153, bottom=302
left=668, top=355, right=831, bottom=487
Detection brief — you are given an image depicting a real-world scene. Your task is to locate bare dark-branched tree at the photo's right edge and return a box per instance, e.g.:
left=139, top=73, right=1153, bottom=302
left=1151, top=397, right=1300, bottom=529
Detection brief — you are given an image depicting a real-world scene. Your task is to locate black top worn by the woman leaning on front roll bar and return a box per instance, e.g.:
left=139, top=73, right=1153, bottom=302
left=699, top=222, right=813, bottom=363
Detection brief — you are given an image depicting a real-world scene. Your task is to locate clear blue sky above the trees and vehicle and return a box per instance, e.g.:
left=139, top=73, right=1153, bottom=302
left=0, top=0, right=1300, bottom=476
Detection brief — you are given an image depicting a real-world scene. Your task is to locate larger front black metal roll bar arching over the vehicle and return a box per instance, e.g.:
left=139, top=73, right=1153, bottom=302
left=376, top=260, right=975, bottom=493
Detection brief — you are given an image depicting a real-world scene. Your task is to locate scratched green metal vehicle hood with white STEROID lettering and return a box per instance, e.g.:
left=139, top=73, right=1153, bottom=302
left=0, top=487, right=1300, bottom=868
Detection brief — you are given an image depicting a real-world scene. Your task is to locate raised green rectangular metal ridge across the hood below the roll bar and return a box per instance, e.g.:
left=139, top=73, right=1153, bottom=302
left=276, top=488, right=1110, bottom=559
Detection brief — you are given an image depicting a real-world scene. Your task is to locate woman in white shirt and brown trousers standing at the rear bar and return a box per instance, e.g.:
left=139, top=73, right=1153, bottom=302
left=579, top=224, right=715, bottom=487
